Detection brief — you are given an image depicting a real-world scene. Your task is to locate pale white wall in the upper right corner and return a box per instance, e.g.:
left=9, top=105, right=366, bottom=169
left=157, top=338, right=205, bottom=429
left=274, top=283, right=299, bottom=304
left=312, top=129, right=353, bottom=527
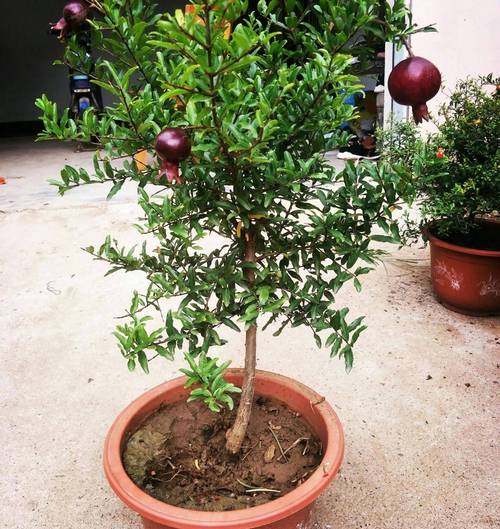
left=412, top=0, right=500, bottom=119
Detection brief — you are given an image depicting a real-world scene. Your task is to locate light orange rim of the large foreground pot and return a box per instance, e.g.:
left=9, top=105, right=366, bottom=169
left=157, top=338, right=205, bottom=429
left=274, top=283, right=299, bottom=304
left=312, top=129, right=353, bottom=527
left=103, top=369, right=344, bottom=529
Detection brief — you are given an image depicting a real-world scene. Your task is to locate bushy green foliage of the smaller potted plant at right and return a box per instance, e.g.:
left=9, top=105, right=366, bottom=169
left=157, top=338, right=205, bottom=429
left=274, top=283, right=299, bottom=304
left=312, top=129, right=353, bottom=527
left=383, top=76, right=500, bottom=237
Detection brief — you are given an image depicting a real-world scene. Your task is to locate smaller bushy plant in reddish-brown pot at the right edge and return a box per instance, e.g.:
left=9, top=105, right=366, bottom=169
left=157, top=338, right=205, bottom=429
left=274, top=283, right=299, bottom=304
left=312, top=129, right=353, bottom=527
left=382, top=75, right=500, bottom=315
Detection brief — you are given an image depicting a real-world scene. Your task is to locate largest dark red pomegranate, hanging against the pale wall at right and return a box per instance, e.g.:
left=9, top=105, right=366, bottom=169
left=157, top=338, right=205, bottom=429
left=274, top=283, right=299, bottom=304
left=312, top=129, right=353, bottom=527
left=389, top=57, right=441, bottom=123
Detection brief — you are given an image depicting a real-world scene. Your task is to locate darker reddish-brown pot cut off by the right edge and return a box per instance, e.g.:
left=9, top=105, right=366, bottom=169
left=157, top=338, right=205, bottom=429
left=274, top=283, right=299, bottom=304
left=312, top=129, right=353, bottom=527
left=426, top=224, right=500, bottom=316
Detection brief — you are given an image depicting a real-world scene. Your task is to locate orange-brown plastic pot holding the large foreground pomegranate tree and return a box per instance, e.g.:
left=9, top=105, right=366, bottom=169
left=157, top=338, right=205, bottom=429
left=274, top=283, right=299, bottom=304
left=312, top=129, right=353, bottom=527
left=104, top=369, right=344, bottom=529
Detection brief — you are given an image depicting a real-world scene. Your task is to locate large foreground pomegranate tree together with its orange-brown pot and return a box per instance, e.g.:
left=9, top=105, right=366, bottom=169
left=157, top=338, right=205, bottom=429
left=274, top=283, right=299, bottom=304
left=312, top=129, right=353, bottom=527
left=38, top=0, right=432, bottom=529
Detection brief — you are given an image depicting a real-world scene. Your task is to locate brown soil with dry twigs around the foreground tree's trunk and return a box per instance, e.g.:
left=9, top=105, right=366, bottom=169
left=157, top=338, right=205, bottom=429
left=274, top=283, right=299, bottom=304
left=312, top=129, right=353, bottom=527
left=123, top=398, right=322, bottom=511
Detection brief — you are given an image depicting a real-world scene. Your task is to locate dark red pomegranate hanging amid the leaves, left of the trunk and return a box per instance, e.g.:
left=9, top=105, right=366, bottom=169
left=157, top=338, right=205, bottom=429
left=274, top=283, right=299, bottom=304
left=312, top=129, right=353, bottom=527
left=155, top=128, right=191, bottom=184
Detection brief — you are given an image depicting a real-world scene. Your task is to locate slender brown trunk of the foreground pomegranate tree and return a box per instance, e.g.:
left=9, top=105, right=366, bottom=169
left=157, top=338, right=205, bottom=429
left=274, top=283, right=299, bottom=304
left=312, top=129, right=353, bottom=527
left=226, top=232, right=257, bottom=454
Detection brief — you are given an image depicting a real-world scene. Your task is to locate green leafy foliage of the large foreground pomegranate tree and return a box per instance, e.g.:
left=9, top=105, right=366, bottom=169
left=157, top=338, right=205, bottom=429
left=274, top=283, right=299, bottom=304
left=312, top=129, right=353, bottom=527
left=38, top=0, right=417, bottom=410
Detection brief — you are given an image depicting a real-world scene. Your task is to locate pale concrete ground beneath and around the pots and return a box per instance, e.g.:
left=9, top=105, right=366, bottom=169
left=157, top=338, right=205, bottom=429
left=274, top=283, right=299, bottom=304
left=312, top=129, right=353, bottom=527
left=0, top=140, right=500, bottom=529
